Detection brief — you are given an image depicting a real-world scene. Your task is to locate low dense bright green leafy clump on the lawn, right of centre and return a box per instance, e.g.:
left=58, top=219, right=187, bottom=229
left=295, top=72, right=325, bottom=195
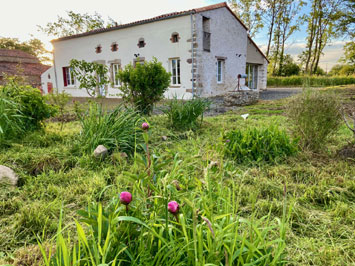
left=224, top=126, right=297, bottom=163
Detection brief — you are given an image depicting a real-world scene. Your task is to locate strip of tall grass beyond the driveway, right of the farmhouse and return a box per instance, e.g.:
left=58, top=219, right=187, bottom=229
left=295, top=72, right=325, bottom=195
left=267, top=76, right=355, bottom=87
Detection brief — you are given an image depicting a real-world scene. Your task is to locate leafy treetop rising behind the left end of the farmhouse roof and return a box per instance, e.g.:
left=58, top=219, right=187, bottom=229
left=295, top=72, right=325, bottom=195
left=37, top=11, right=117, bottom=38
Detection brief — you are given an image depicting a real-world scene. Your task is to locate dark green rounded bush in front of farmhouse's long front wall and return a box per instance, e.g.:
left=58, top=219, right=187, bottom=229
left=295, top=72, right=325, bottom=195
left=118, top=58, right=170, bottom=114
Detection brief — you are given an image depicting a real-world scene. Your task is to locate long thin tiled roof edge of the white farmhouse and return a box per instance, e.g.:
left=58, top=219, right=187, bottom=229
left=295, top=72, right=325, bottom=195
left=52, top=2, right=248, bottom=42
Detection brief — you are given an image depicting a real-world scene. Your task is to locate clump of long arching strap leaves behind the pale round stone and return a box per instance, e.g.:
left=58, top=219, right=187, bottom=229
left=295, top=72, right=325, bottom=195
left=78, top=103, right=142, bottom=154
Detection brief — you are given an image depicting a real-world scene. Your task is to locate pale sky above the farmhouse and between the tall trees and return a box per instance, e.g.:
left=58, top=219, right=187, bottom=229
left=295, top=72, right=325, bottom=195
left=0, top=0, right=344, bottom=71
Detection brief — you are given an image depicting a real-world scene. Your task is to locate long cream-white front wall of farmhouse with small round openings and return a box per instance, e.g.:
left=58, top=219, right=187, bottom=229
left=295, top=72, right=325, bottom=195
left=53, top=15, right=192, bottom=99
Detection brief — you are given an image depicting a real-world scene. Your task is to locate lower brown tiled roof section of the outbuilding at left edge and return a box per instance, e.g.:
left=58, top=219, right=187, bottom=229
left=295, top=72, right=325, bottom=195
left=0, top=62, right=50, bottom=76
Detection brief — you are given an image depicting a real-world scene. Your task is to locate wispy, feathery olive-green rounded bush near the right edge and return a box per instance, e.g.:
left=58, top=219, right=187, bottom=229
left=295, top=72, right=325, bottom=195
left=287, top=90, right=341, bottom=149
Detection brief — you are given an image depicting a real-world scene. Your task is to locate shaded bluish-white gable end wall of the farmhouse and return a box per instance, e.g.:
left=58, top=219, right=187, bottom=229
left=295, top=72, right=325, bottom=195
left=195, top=8, right=248, bottom=96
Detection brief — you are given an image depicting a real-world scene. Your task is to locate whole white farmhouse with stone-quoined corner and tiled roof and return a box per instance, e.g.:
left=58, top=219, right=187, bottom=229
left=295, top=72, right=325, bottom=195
left=41, top=3, right=268, bottom=99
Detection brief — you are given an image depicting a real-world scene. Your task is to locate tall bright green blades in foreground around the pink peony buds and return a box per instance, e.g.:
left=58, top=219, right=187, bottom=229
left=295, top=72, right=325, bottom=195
left=39, top=167, right=289, bottom=266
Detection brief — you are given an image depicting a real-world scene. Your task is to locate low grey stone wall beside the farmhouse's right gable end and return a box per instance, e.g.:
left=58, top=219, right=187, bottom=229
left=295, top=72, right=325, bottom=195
left=208, top=90, right=259, bottom=113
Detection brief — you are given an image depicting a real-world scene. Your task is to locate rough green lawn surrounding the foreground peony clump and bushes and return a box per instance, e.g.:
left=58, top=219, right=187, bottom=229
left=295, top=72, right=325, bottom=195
left=0, top=87, right=355, bottom=265
